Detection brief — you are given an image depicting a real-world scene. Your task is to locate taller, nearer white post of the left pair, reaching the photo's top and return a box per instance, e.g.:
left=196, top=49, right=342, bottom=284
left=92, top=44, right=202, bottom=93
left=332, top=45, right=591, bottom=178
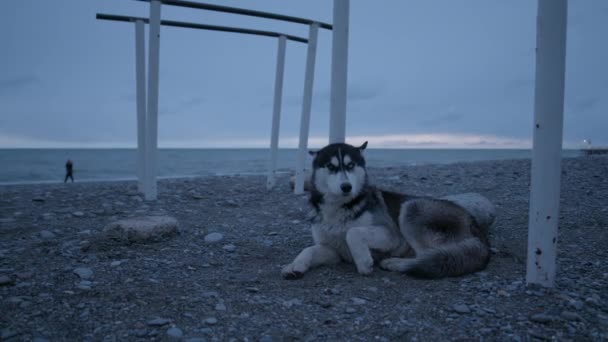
left=144, top=0, right=161, bottom=200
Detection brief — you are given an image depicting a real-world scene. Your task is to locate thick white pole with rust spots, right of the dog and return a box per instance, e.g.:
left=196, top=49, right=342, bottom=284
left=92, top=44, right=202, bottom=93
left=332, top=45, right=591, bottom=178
left=526, top=0, right=568, bottom=287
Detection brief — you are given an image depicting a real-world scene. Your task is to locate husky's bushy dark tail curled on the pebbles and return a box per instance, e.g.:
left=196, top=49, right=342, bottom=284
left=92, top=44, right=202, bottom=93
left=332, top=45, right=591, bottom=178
left=404, top=237, right=490, bottom=278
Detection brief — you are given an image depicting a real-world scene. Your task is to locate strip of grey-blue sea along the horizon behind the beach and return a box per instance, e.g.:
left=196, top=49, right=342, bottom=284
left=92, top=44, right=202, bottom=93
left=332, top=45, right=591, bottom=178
left=0, top=148, right=580, bottom=185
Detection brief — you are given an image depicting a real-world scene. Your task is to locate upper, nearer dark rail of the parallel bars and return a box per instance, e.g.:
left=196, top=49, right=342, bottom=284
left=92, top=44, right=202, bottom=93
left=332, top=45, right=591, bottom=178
left=137, top=0, right=333, bottom=30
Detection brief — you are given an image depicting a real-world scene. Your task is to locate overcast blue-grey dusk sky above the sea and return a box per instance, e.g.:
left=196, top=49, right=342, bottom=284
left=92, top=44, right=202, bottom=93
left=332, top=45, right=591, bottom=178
left=0, top=0, right=608, bottom=148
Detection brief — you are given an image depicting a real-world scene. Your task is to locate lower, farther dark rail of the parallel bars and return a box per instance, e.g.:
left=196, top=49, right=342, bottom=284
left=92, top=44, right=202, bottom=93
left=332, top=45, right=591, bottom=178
left=96, top=13, right=308, bottom=43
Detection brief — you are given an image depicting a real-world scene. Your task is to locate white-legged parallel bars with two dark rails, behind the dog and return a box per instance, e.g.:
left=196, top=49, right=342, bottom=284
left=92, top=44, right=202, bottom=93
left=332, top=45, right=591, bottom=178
left=96, top=0, right=332, bottom=200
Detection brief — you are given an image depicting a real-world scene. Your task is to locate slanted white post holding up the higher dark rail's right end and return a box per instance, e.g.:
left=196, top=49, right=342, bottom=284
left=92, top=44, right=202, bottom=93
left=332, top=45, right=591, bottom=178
left=294, top=23, right=319, bottom=195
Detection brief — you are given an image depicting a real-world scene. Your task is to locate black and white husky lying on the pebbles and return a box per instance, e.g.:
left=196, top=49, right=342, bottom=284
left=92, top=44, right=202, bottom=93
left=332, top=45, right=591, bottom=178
left=281, top=142, right=493, bottom=279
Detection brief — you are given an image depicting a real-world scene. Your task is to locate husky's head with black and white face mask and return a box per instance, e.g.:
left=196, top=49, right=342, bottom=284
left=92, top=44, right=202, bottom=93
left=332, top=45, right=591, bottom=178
left=311, top=141, right=367, bottom=203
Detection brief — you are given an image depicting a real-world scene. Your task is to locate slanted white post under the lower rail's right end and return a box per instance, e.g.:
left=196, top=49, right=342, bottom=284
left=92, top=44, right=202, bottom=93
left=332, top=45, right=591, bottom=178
left=266, top=36, right=286, bottom=189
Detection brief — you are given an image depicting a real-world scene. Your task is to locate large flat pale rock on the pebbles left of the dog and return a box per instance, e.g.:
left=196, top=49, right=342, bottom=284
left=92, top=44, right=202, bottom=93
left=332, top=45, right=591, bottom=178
left=103, top=216, right=178, bottom=243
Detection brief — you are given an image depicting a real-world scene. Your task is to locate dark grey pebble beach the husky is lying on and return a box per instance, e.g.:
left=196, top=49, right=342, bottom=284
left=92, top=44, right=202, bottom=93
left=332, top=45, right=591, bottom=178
left=0, top=156, right=608, bottom=342
